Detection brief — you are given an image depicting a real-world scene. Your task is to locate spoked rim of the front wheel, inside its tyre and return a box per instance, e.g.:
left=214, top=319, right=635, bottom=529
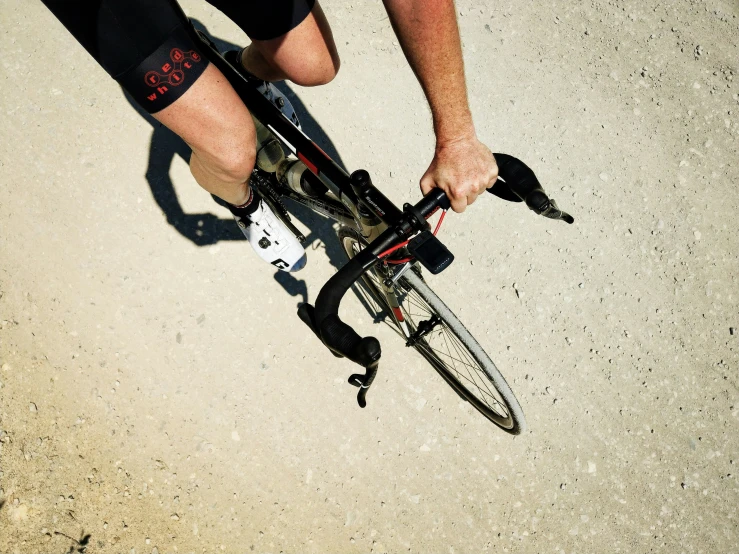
left=342, top=230, right=514, bottom=429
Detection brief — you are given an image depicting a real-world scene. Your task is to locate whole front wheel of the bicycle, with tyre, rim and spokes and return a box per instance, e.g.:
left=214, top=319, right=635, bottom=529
left=339, top=228, right=526, bottom=435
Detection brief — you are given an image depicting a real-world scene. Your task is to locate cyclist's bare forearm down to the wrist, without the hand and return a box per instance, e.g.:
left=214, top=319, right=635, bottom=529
left=383, top=0, right=475, bottom=144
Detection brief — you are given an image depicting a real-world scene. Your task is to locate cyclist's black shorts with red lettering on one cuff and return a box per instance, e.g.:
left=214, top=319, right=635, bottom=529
left=42, top=0, right=315, bottom=113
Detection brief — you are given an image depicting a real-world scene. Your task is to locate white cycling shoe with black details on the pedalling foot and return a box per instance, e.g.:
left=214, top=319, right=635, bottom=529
left=234, top=198, right=308, bottom=271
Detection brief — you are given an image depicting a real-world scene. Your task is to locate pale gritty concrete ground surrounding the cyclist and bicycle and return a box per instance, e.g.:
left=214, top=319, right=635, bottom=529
left=0, top=0, right=739, bottom=554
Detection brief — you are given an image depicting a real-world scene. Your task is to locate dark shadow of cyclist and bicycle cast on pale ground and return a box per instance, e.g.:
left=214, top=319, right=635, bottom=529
left=124, top=20, right=354, bottom=302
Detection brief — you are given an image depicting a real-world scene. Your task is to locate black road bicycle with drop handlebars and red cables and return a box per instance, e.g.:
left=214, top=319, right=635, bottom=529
left=191, top=17, right=573, bottom=435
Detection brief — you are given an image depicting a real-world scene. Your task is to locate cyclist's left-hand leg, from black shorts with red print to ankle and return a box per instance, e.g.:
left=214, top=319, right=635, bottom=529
left=43, top=0, right=256, bottom=205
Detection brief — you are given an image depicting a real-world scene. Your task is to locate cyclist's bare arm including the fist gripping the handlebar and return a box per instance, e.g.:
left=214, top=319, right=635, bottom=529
left=384, top=0, right=498, bottom=212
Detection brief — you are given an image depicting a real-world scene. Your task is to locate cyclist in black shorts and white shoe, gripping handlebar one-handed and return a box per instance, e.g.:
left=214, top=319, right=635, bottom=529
left=42, top=0, right=498, bottom=271
